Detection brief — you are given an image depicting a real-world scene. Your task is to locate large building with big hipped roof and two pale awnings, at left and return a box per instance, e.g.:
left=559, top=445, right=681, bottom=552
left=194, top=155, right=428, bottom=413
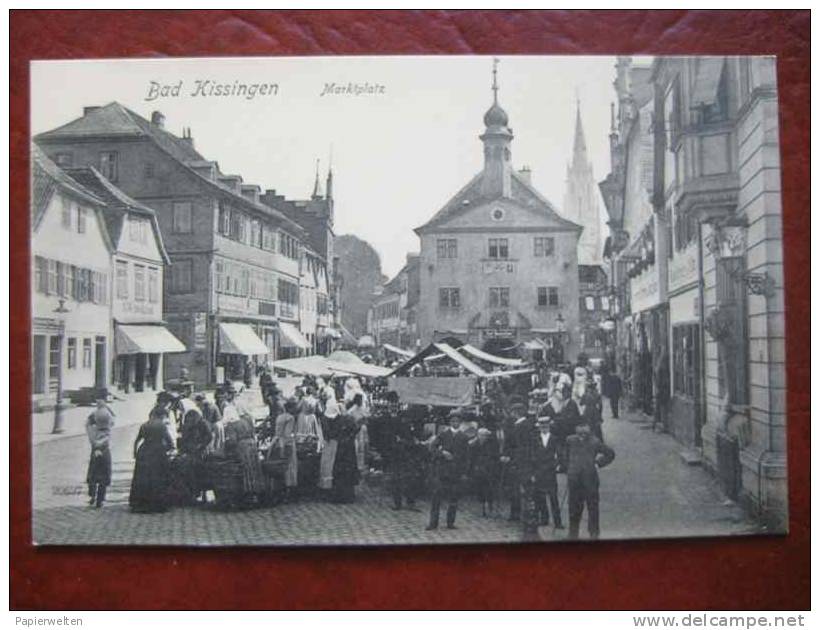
left=35, top=103, right=332, bottom=383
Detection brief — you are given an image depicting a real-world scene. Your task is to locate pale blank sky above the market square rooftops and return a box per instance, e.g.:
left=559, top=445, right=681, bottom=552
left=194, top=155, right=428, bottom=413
left=31, top=56, right=615, bottom=275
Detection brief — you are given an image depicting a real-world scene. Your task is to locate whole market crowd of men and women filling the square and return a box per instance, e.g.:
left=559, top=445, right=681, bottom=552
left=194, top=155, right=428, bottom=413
left=86, top=361, right=620, bottom=538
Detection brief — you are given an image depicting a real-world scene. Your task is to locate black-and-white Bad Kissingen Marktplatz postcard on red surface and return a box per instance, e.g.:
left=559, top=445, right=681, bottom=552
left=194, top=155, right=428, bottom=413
left=30, top=56, right=788, bottom=546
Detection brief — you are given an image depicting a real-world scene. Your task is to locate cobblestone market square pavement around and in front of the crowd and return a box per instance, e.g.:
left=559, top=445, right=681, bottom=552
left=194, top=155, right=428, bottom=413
left=33, top=402, right=764, bottom=546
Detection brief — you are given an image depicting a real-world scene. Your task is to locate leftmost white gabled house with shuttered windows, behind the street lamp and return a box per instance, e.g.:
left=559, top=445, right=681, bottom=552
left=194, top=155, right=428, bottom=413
left=31, top=146, right=113, bottom=407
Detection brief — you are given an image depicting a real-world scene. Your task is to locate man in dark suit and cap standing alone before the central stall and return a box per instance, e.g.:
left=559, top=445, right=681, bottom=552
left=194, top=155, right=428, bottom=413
left=427, top=409, right=470, bottom=530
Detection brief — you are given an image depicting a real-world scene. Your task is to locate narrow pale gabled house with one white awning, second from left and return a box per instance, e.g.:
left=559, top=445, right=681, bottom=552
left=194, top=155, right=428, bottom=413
left=66, top=167, right=185, bottom=393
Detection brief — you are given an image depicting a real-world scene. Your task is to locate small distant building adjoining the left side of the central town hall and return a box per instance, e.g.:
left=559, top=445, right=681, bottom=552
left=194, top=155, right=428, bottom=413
left=368, top=254, right=421, bottom=351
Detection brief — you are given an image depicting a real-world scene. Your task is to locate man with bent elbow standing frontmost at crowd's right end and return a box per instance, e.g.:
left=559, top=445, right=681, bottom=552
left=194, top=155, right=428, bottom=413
left=567, top=421, right=615, bottom=540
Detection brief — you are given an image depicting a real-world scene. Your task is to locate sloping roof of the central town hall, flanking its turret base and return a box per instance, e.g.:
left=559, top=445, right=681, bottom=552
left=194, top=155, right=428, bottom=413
left=415, top=170, right=583, bottom=234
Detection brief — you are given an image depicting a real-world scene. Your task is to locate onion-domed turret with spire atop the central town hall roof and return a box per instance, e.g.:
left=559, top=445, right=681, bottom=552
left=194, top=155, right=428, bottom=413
left=480, top=59, right=513, bottom=198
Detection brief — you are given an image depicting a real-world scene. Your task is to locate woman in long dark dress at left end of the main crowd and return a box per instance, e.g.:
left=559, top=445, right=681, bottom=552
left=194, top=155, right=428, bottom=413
left=128, top=408, right=174, bottom=512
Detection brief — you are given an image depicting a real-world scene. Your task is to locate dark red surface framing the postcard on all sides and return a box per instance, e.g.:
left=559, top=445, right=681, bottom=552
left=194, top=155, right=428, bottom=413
left=9, top=11, right=810, bottom=609
